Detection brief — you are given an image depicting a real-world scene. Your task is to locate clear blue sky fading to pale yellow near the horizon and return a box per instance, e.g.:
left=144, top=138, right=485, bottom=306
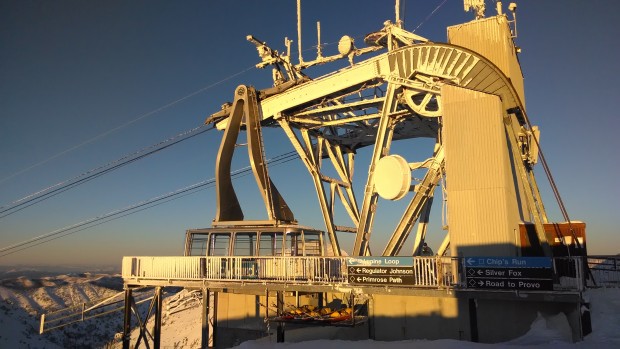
left=0, top=0, right=620, bottom=265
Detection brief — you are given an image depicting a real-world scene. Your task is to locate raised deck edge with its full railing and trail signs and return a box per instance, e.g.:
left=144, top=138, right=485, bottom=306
left=122, top=256, right=584, bottom=301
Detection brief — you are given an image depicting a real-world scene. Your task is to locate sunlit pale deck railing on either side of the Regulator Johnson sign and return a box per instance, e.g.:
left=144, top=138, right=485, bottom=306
left=122, top=257, right=458, bottom=287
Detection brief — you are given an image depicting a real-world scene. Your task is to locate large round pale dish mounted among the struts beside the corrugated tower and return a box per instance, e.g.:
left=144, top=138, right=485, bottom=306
left=374, top=155, right=411, bottom=200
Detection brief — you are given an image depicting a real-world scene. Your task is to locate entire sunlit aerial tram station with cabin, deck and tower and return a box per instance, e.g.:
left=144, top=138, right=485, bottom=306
left=40, top=0, right=591, bottom=348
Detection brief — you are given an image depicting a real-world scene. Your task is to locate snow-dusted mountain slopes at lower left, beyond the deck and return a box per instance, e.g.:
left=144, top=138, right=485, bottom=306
left=0, top=268, right=123, bottom=348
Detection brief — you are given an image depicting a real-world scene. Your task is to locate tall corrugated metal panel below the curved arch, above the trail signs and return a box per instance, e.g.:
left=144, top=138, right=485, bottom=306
left=441, top=85, right=520, bottom=256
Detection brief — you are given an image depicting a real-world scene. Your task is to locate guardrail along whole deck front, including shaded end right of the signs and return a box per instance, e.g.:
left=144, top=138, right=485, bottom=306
left=122, top=256, right=585, bottom=291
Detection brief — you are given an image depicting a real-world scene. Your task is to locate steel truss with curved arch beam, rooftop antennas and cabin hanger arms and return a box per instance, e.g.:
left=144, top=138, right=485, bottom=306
left=206, top=24, right=550, bottom=256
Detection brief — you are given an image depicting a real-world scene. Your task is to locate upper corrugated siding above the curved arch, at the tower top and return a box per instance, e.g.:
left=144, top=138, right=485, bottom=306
left=448, top=15, right=525, bottom=106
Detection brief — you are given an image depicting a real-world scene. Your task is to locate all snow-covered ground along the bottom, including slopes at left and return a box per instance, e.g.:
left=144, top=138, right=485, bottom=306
left=0, top=273, right=620, bottom=349
